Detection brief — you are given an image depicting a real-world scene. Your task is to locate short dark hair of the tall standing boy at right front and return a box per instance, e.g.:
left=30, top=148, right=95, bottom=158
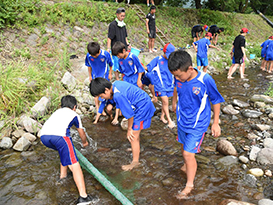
left=168, top=50, right=192, bottom=72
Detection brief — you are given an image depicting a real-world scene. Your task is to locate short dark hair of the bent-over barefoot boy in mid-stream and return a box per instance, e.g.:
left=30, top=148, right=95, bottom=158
left=89, top=77, right=112, bottom=97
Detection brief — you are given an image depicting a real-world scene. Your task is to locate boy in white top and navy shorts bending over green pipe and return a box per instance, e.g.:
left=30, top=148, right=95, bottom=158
left=41, top=95, right=93, bottom=204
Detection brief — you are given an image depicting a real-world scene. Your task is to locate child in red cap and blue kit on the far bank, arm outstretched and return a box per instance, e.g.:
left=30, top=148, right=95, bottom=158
left=192, top=32, right=219, bottom=72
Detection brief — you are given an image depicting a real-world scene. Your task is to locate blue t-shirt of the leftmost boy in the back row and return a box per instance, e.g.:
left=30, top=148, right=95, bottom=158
left=85, top=50, right=113, bottom=80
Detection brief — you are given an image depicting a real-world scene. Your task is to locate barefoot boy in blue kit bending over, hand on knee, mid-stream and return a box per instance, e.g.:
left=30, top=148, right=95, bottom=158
left=89, top=78, right=155, bottom=171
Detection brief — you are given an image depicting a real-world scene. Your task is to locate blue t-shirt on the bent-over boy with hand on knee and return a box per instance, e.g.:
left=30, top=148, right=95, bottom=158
left=113, top=81, right=155, bottom=122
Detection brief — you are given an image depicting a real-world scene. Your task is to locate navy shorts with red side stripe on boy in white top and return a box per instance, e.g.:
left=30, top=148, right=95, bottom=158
left=41, top=135, right=78, bottom=166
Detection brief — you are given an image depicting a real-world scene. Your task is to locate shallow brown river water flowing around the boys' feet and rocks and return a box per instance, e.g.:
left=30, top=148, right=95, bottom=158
left=0, top=68, right=270, bottom=205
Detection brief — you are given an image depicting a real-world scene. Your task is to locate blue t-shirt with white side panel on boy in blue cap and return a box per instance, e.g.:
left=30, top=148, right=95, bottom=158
left=147, top=56, right=174, bottom=92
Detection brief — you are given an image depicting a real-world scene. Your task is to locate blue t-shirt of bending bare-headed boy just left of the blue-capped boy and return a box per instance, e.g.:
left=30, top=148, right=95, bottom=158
left=118, top=53, right=145, bottom=86
